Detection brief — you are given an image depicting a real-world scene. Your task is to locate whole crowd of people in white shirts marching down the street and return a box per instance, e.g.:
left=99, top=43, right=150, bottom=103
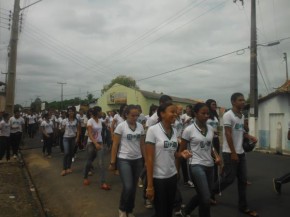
left=0, top=93, right=290, bottom=217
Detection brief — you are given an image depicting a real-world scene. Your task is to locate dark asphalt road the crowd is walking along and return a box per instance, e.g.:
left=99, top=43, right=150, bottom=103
left=22, top=138, right=290, bottom=217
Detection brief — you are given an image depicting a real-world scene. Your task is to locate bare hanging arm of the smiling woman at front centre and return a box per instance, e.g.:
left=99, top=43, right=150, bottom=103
left=145, top=143, right=155, bottom=200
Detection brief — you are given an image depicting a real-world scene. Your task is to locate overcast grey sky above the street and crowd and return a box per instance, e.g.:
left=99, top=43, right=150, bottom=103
left=0, top=0, right=290, bottom=106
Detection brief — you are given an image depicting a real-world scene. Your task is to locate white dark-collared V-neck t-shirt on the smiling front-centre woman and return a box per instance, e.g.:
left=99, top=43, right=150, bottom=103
left=145, top=123, right=177, bottom=179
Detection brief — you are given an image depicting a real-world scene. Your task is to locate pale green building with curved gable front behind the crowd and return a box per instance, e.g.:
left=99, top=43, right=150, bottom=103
left=97, top=84, right=198, bottom=115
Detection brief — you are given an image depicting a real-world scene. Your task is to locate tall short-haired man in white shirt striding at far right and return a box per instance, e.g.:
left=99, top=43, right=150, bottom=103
left=212, top=93, right=258, bottom=216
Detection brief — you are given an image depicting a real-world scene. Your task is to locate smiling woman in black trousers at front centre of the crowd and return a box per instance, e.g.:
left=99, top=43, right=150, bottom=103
left=145, top=102, right=189, bottom=217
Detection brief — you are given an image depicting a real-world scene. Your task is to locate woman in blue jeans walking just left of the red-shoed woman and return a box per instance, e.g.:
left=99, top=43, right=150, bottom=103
left=61, top=107, right=80, bottom=176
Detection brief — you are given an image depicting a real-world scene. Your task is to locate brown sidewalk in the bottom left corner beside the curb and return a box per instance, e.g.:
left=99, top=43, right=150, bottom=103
left=0, top=155, right=45, bottom=217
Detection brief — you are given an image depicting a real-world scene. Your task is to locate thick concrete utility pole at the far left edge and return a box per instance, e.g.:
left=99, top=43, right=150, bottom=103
left=5, top=0, right=41, bottom=114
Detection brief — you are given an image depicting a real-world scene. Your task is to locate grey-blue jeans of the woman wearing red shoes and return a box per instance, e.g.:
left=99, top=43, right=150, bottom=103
left=84, top=142, right=106, bottom=184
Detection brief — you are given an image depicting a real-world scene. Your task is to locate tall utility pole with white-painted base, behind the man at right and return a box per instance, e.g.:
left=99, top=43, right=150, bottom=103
left=249, top=0, right=258, bottom=136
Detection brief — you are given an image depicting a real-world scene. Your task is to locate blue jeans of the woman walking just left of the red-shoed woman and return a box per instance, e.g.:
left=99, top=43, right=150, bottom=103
left=63, top=137, right=76, bottom=170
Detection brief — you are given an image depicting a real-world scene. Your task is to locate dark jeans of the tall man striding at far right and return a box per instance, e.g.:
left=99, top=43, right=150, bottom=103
left=213, top=152, right=248, bottom=210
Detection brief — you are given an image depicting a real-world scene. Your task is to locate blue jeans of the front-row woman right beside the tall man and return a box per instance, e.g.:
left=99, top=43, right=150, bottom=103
left=184, top=165, right=214, bottom=217
